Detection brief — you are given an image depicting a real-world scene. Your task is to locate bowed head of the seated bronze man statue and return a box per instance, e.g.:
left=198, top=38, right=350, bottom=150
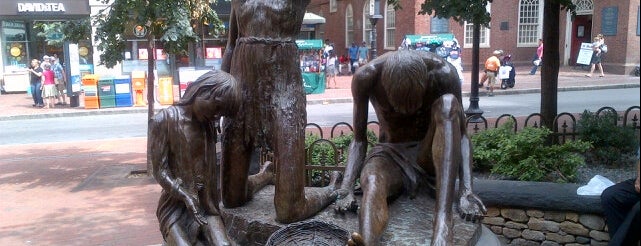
left=381, top=50, right=428, bottom=114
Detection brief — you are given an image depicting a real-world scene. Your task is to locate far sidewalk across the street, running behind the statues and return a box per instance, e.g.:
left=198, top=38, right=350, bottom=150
left=0, top=64, right=639, bottom=120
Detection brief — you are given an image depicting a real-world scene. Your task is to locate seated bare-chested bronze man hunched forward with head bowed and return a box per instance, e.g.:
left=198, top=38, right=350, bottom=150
left=336, top=51, right=486, bottom=246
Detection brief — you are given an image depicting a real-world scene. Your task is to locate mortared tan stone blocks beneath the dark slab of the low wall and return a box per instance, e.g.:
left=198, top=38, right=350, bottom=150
left=483, top=207, right=610, bottom=246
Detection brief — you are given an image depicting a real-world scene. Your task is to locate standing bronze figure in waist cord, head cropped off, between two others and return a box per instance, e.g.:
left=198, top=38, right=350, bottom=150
left=221, top=0, right=339, bottom=223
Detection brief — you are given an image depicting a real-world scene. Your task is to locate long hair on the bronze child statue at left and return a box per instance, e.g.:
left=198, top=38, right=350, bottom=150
left=175, top=70, right=241, bottom=113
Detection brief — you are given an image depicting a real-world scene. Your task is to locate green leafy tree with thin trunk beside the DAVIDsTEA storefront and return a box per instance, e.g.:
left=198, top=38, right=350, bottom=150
left=93, top=0, right=223, bottom=121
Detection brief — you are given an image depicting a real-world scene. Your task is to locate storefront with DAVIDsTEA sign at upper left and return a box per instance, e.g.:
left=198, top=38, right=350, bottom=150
left=0, top=0, right=92, bottom=92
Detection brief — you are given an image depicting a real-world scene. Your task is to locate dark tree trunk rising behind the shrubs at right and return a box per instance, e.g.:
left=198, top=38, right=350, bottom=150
left=541, top=1, right=561, bottom=133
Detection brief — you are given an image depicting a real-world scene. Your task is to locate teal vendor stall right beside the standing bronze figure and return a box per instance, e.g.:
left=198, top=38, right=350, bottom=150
left=296, top=39, right=325, bottom=94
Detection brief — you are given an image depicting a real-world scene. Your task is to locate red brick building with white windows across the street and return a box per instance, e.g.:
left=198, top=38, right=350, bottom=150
left=307, top=0, right=640, bottom=74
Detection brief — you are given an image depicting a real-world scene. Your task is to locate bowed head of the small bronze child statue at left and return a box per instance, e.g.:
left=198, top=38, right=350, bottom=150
left=176, top=70, right=241, bottom=120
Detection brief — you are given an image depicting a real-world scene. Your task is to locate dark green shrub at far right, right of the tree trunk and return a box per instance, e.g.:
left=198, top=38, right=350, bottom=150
left=577, top=110, right=639, bottom=167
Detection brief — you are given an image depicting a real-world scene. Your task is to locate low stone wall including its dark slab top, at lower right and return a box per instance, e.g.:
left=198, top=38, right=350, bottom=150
left=474, top=179, right=610, bottom=246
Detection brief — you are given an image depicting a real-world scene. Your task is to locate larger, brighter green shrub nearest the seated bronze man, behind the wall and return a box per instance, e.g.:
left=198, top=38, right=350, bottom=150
left=472, top=121, right=591, bottom=183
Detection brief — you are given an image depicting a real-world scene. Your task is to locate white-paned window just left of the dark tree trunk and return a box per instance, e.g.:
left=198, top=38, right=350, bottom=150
left=516, top=0, right=543, bottom=47
